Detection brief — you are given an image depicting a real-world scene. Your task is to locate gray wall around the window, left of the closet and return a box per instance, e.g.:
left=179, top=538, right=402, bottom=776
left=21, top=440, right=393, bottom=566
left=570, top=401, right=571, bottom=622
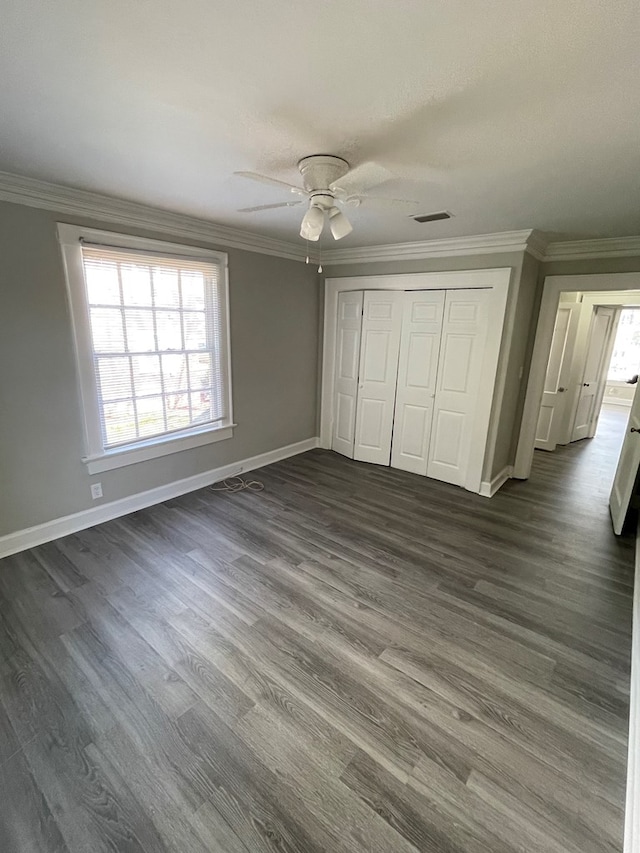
left=0, top=203, right=319, bottom=536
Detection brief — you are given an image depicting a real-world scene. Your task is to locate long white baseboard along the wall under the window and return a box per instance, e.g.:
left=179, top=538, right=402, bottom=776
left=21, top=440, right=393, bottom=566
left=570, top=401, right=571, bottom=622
left=0, top=437, right=320, bottom=557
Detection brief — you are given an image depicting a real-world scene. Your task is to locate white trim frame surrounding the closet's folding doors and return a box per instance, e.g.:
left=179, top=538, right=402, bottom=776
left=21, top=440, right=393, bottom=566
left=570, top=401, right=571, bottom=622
left=320, top=267, right=512, bottom=492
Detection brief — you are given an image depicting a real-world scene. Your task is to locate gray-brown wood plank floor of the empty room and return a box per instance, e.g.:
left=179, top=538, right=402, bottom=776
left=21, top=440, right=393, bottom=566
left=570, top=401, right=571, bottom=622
left=0, top=412, right=633, bottom=853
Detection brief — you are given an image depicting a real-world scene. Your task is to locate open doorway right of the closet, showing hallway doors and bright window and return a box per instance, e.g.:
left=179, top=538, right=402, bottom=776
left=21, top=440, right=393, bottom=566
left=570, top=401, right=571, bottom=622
left=535, top=291, right=640, bottom=452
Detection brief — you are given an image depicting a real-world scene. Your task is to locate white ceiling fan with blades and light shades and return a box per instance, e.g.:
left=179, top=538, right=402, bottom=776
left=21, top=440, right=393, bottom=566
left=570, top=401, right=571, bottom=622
left=234, top=154, right=418, bottom=241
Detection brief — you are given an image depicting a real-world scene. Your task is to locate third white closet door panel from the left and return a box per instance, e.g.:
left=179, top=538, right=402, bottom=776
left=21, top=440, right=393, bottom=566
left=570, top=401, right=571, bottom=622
left=391, top=290, right=445, bottom=475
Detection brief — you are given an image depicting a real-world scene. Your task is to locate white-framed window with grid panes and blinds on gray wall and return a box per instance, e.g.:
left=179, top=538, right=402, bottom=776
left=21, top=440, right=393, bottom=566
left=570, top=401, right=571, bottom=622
left=58, top=225, right=232, bottom=473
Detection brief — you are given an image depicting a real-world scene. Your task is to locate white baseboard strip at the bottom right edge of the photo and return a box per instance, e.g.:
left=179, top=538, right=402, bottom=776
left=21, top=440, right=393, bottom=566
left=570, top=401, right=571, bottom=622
left=624, top=528, right=640, bottom=853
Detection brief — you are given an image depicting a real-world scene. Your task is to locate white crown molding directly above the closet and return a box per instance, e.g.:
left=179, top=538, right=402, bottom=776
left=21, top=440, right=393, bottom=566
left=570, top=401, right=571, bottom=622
left=322, top=230, right=546, bottom=265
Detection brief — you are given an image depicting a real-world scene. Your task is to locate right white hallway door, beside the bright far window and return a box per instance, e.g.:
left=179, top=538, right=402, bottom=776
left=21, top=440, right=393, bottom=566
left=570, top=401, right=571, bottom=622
left=571, top=305, right=620, bottom=441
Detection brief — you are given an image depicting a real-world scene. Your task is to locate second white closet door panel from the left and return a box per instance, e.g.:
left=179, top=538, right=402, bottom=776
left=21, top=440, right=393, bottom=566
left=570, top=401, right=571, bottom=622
left=354, top=290, right=404, bottom=465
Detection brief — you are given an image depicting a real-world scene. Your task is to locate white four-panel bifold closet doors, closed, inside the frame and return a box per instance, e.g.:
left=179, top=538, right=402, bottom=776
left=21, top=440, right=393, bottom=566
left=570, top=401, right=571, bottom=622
left=331, top=288, right=498, bottom=486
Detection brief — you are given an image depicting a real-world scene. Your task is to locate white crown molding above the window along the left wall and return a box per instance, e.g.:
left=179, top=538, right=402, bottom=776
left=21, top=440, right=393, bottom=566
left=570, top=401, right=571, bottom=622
left=0, top=172, right=306, bottom=262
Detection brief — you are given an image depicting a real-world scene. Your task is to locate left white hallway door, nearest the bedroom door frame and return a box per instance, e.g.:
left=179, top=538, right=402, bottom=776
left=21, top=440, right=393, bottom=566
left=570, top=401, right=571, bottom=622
left=535, top=302, right=580, bottom=450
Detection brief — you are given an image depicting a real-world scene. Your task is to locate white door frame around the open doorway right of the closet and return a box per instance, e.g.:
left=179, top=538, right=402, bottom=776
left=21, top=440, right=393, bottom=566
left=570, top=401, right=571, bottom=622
left=513, top=272, right=640, bottom=480
